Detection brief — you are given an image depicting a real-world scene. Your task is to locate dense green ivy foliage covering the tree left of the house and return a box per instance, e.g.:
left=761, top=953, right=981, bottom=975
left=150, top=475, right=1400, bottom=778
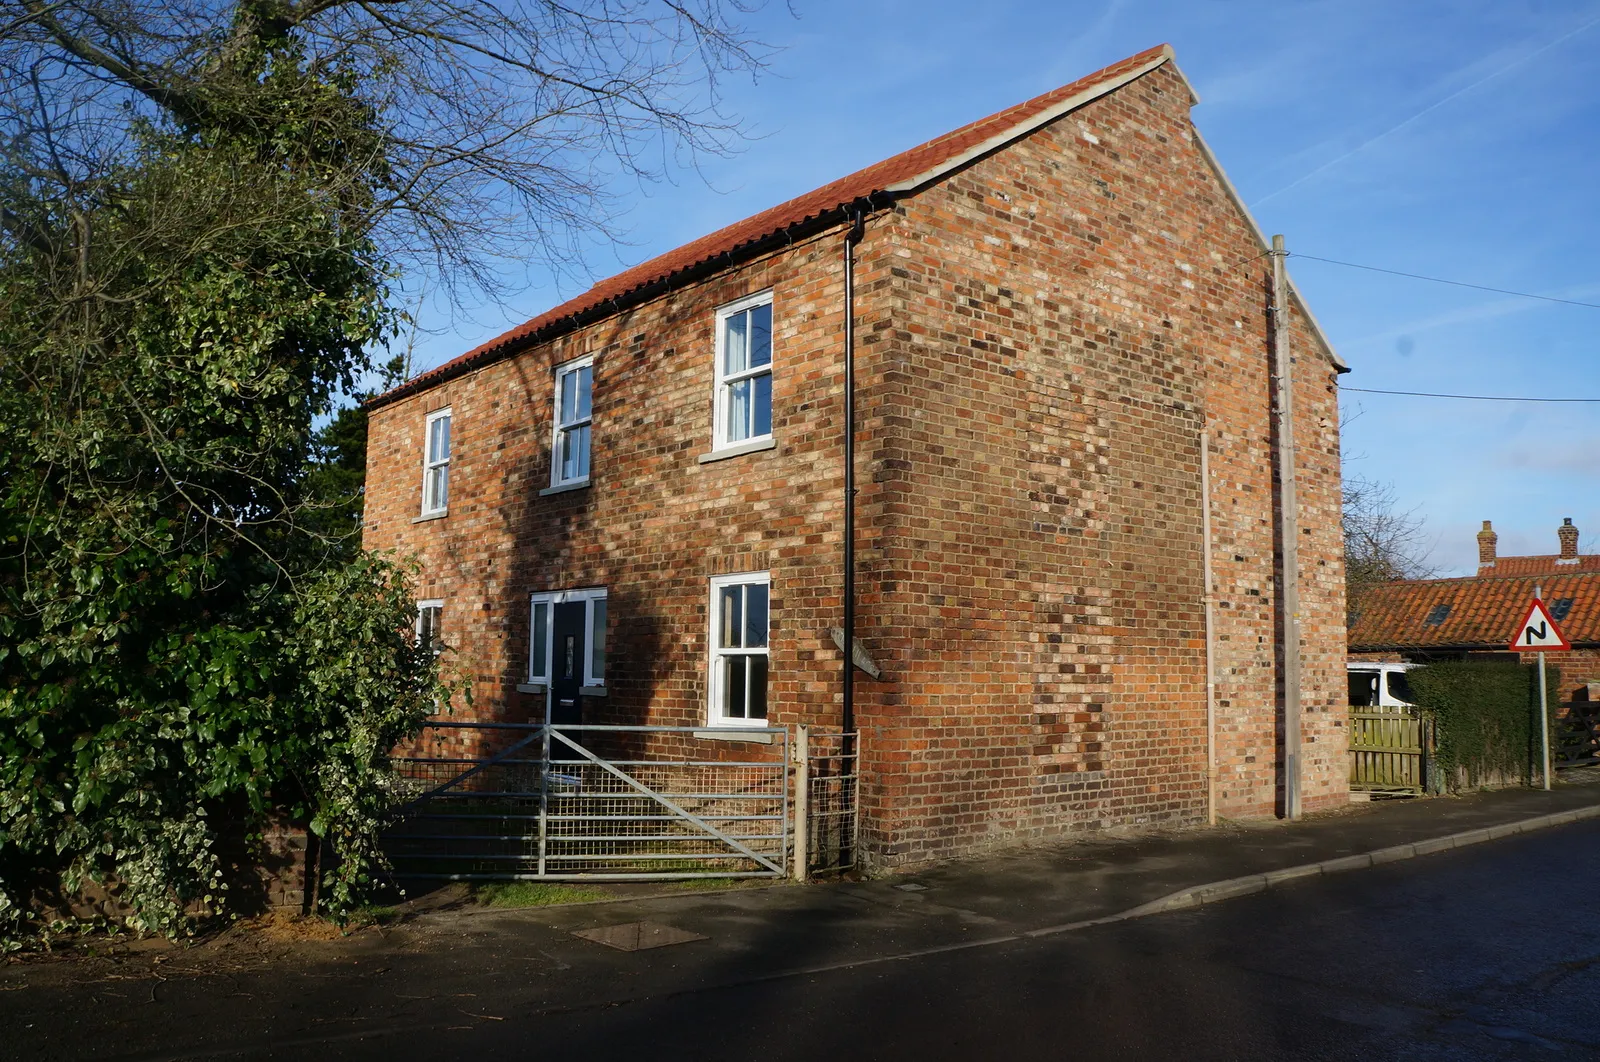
left=0, top=42, right=448, bottom=947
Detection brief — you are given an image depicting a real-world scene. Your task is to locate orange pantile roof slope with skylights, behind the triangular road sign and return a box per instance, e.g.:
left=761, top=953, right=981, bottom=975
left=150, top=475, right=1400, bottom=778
left=1350, top=569, right=1600, bottom=653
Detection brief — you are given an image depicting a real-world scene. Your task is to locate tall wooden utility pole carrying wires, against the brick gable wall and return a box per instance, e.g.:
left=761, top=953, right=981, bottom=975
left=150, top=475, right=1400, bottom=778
left=1270, top=235, right=1301, bottom=819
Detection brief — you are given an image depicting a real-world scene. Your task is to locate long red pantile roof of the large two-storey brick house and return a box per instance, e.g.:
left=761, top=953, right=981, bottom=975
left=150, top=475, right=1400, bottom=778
left=368, top=45, right=1173, bottom=408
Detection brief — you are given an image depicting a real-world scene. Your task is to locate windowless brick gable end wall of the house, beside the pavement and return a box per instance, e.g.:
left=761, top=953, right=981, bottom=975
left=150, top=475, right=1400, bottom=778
left=864, top=69, right=1349, bottom=859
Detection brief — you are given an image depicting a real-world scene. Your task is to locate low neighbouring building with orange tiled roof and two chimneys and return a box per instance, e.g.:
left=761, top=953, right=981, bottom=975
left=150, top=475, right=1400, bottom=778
left=1350, top=518, right=1600, bottom=702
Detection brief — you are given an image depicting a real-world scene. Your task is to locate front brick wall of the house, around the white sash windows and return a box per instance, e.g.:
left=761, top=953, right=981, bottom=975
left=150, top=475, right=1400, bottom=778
left=365, top=231, right=864, bottom=738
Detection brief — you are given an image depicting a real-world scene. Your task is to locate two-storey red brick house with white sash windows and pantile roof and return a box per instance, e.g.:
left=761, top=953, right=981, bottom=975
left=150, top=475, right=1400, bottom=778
left=365, top=46, right=1347, bottom=865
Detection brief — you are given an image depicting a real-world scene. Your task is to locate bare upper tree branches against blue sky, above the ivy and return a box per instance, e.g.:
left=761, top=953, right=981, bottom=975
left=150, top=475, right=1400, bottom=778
left=0, top=0, right=765, bottom=301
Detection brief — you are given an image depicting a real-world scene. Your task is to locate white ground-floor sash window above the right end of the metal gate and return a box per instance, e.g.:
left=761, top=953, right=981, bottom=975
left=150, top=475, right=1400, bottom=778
left=707, top=571, right=771, bottom=726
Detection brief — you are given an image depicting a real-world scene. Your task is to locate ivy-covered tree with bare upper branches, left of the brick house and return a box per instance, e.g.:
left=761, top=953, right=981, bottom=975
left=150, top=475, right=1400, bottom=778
left=0, top=0, right=768, bottom=945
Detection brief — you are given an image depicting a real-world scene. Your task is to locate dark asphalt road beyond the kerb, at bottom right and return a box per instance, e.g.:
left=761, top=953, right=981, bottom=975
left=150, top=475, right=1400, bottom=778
left=432, top=825, right=1600, bottom=1062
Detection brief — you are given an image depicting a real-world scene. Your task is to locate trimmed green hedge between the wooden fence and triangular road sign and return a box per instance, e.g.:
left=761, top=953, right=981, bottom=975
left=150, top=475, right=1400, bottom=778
left=1406, top=661, right=1562, bottom=790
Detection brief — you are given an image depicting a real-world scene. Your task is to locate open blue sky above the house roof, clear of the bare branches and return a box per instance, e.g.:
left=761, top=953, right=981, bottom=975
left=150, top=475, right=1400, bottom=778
left=406, top=0, right=1600, bottom=574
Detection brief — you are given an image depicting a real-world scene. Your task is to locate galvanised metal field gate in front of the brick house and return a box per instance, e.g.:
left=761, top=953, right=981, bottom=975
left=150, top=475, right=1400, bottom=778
left=384, top=723, right=789, bottom=881
